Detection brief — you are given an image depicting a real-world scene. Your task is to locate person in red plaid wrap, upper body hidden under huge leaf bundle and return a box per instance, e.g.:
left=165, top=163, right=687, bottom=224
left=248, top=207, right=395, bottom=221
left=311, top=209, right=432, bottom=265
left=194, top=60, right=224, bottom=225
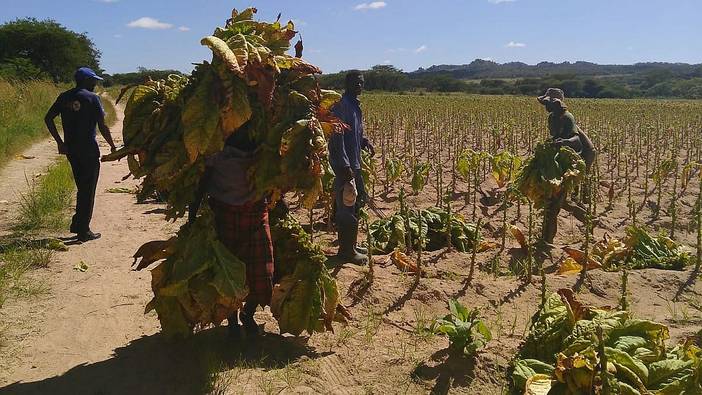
left=188, top=126, right=274, bottom=340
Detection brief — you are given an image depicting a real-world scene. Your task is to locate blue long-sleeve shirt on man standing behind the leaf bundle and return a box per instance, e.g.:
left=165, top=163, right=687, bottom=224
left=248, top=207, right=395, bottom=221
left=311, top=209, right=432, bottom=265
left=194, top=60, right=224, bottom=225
left=329, top=93, right=368, bottom=174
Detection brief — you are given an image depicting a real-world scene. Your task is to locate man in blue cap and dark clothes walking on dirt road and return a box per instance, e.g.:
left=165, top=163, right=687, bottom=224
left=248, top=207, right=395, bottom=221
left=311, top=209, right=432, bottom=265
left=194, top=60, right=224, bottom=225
left=44, top=67, right=116, bottom=242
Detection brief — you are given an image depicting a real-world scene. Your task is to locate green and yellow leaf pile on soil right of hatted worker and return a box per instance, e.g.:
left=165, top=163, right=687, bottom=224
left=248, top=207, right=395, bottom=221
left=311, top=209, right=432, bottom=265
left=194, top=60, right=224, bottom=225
left=559, top=226, right=691, bottom=274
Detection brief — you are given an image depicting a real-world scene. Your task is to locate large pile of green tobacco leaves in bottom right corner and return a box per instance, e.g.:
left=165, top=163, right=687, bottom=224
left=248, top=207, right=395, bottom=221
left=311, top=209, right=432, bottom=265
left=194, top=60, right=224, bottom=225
left=512, top=289, right=702, bottom=395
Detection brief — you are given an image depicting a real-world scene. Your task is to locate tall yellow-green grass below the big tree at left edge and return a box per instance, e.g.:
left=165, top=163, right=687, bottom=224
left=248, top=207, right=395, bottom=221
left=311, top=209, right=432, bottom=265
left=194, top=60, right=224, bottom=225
left=0, top=79, right=62, bottom=166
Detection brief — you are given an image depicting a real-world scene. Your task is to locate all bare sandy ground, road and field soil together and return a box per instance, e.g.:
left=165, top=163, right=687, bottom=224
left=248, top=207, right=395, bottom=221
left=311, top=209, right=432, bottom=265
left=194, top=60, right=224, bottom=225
left=0, top=103, right=702, bottom=394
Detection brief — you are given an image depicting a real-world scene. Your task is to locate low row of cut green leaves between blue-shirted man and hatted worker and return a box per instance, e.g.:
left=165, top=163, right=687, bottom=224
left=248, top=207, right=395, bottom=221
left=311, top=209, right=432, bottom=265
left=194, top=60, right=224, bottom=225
left=370, top=207, right=479, bottom=254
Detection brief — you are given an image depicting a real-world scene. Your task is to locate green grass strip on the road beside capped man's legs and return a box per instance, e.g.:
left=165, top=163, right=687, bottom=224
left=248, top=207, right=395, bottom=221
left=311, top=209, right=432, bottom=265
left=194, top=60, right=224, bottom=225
left=14, top=158, right=75, bottom=232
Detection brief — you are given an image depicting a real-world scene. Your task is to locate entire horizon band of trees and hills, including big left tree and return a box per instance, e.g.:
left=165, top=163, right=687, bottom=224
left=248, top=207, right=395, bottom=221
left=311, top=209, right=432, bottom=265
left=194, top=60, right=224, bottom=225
left=0, top=18, right=702, bottom=99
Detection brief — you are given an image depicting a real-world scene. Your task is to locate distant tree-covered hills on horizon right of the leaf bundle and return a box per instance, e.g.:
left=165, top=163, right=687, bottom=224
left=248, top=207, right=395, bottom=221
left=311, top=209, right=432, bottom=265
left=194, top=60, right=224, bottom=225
left=320, top=59, right=702, bottom=99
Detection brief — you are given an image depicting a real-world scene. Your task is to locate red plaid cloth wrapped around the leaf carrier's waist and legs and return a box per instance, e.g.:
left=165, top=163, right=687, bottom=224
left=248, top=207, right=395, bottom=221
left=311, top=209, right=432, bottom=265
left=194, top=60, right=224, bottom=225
left=210, top=198, right=273, bottom=306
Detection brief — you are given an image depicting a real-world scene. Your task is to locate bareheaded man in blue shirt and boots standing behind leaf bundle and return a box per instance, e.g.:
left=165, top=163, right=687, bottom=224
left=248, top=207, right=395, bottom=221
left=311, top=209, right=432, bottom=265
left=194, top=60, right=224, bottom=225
left=329, top=70, right=374, bottom=265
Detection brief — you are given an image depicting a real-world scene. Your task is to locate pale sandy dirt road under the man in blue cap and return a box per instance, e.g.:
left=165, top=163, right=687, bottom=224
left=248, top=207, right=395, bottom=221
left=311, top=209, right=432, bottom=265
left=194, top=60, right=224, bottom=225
left=0, top=103, right=192, bottom=394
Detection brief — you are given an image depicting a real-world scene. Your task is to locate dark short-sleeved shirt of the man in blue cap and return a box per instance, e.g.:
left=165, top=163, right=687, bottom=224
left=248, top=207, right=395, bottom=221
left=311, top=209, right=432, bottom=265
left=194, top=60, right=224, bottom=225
left=51, top=88, right=105, bottom=156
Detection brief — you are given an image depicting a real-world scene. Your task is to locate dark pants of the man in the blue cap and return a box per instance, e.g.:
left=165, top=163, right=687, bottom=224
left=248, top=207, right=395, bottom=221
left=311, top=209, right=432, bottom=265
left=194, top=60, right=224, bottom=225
left=66, top=154, right=100, bottom=234
